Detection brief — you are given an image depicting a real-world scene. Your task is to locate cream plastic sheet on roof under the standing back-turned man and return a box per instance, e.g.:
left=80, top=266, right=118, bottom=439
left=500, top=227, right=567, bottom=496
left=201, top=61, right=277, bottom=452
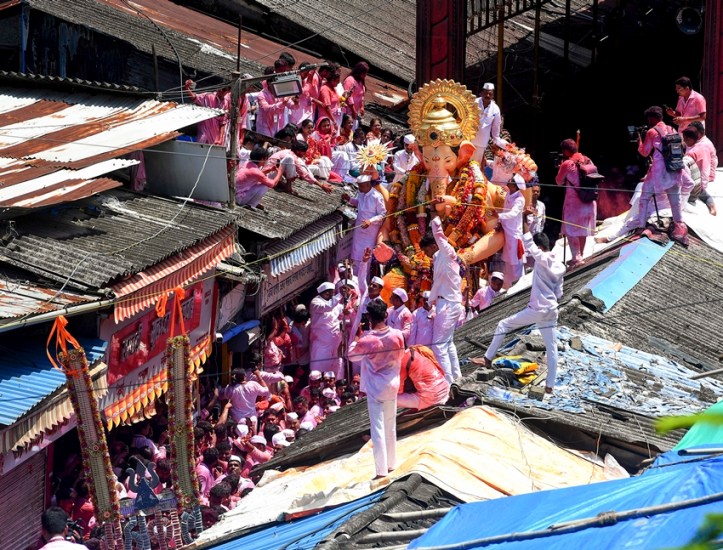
left=198, top=407, right=620, bottom=543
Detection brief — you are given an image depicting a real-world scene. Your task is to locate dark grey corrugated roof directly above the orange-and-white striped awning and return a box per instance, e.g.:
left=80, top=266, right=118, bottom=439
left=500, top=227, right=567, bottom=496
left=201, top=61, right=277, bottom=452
left=0, top=189, right=235, bottom=291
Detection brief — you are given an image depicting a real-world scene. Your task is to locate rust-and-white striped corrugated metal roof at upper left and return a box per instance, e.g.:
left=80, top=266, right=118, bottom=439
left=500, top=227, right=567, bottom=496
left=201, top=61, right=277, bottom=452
left=0, top=86, right=217, bottom=208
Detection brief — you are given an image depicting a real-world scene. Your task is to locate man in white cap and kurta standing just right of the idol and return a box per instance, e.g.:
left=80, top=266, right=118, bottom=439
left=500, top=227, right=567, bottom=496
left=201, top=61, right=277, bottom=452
left=498, top=174, right=526, bottom=288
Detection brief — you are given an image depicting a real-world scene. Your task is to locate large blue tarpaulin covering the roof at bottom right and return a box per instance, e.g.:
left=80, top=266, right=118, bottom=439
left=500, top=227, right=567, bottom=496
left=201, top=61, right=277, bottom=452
left=409, top=457, right=723, bottom=550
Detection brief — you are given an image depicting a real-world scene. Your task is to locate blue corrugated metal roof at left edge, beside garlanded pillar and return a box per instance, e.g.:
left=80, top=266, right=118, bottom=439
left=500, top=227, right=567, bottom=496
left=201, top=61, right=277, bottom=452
left=0, top=339, right=107, bottom=426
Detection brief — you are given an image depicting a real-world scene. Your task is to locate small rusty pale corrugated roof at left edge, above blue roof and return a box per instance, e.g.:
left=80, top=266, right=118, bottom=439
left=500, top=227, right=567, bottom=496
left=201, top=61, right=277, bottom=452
left=0, top=278, right=98, bottom=319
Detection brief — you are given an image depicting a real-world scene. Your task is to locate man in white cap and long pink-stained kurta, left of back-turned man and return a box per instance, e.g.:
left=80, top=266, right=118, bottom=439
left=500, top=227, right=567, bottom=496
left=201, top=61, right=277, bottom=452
left=309, top=282, right=344, bottom=380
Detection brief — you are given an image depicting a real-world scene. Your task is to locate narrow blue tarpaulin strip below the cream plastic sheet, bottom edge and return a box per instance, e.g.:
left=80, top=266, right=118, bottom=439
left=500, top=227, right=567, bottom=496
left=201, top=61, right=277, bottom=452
left=206, top=491, right=384, bottom=550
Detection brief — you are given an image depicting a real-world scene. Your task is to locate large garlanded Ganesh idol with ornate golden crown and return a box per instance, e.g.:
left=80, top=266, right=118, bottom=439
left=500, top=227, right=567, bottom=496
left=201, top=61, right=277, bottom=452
left=364, top=80, right=537, bottom=303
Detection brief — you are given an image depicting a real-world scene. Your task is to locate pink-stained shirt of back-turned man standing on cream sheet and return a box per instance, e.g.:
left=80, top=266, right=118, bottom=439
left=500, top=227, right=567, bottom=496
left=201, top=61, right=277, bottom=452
left=349, top=326, right=404, bottom=401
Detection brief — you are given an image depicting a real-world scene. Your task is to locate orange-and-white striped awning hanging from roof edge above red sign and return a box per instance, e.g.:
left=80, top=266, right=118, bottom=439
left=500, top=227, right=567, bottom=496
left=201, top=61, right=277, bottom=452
left=111, top=225, right=236, bottom=323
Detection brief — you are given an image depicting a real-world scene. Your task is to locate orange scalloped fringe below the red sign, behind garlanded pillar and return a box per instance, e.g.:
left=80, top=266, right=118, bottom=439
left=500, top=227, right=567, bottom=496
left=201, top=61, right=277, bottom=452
left=103, top=335, right=211, bottom=430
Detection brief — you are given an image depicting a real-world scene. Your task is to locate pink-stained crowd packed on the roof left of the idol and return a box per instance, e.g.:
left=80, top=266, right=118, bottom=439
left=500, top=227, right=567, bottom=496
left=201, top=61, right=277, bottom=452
left=185, top=53, right=419, bottom=213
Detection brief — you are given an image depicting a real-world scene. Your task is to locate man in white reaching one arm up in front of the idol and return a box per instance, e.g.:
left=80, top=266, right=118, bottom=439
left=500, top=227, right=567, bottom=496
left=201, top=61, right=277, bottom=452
left=419, top=217, right=464, bottom=384
